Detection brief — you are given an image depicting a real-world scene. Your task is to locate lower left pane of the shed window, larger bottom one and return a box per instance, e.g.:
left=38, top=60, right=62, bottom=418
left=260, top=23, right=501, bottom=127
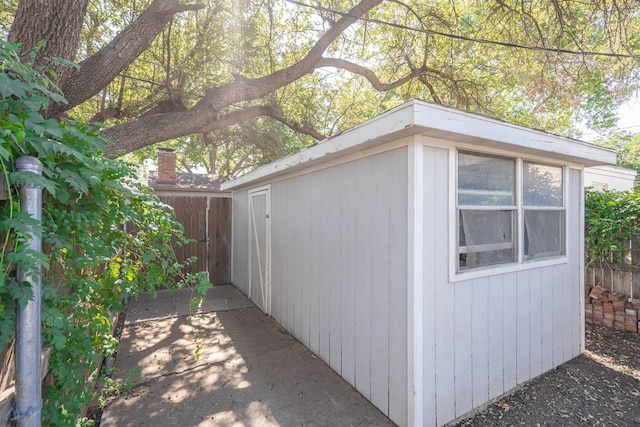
left=458, top=209, right=516, bottom=270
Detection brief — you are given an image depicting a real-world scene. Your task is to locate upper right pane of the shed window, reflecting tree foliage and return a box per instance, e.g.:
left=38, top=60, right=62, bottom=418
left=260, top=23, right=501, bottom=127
left=523, top=162, right=563, bottom=207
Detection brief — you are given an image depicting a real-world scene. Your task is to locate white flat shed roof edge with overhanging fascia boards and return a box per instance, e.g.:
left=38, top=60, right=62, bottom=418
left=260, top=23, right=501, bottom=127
left=222, top=99, right=616, bottom=190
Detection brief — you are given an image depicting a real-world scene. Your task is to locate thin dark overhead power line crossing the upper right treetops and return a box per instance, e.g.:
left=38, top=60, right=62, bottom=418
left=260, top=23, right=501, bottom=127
left=285, top=0, right=640, bottom=59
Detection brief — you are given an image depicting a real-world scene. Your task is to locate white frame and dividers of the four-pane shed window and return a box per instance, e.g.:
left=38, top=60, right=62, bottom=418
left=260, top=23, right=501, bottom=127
left=449, top=147, right=570, bottom=282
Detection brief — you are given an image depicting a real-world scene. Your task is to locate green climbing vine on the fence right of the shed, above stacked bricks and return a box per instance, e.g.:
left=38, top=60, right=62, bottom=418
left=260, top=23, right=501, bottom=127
left=585, top=189, right=640, bottom=266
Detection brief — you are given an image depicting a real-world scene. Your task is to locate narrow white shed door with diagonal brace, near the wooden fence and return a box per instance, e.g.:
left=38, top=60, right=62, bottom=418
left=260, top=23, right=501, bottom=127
left=249, top=188, right=271, bottom=314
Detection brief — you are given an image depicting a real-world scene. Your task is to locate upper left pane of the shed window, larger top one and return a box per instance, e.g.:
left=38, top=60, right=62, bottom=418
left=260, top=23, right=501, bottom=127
left=458, top=151, right=515, bottom=206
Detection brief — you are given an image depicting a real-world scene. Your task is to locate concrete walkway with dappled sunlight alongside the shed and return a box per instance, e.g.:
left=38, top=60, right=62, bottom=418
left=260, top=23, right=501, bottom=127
left=100, top=285, right=393, bottom=427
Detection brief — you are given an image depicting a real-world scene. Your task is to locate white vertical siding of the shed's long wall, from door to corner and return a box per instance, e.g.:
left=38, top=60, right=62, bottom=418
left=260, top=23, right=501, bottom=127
left=258, top=148, right=408, bottom=425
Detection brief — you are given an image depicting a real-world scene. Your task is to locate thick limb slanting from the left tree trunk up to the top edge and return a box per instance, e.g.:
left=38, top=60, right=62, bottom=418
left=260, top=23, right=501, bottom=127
left=47, top=0, right=204, bottom=117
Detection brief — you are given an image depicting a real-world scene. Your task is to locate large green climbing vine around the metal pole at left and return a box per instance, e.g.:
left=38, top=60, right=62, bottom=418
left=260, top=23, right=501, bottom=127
left=0, top=42, right=210, bottom=426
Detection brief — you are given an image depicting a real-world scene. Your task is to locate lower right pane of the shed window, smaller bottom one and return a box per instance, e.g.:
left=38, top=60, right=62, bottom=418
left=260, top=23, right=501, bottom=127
left=524, top=209, right=565, bottom=259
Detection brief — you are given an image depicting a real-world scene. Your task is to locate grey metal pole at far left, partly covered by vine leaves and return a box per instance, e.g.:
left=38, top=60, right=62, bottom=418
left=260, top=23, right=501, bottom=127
left=14, top=156, right=43, bottom=427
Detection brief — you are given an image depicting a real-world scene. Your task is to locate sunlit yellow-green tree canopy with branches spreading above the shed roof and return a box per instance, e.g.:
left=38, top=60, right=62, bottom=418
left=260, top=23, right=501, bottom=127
left=0, top=0, right=640, bottom=175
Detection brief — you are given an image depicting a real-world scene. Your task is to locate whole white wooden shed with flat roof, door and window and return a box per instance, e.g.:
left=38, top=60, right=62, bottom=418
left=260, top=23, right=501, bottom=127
left=223, top=100, right=615, bottom=426
